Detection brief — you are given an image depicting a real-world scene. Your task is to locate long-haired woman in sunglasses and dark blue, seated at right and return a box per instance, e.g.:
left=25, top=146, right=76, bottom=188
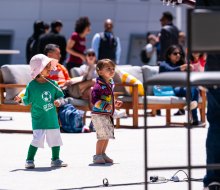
left=159, top=45, right=200, bottom=125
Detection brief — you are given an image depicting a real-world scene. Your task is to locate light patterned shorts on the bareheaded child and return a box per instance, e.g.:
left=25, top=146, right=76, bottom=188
left=91, top=114, right=115, bottom=140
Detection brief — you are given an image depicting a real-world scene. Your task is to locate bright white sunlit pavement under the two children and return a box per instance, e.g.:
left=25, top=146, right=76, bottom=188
left=0, top=112, right=207, bottom=190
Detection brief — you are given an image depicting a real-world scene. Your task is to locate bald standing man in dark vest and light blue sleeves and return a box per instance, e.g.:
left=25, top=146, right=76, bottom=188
left=92, top=19, right=121, bottom=64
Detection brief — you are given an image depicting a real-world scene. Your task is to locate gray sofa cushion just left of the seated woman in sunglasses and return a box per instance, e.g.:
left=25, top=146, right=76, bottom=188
left=142, top=65, right=159, bottom=95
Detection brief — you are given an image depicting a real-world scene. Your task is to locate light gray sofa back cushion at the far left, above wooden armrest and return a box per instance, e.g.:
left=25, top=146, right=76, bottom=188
left=1, top=65, right=32, bottom=100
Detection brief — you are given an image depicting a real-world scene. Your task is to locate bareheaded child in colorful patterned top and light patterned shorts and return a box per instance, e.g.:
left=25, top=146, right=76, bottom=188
left=92, top=59, right=122, bottom=164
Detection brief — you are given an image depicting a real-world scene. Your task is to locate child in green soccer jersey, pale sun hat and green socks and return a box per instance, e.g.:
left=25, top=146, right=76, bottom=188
left=15, top=54, right=67, bottom=169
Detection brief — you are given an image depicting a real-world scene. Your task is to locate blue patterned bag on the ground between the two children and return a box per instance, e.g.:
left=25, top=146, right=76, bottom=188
left=58, top=104, right=84, bottom=133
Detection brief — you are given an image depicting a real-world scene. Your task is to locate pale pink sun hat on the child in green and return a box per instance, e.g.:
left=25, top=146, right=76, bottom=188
left=30, top=54, right=57, bottom=78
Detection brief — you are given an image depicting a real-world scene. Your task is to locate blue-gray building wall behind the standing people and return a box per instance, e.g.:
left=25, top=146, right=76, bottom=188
left=0, top=0, right=185, bottom=64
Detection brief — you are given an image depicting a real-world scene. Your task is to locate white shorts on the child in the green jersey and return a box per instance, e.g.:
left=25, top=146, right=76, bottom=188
left=31, top=129, right=63, bottom=148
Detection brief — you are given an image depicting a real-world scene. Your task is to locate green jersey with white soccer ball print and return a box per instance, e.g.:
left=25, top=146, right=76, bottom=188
left=23, top=80, right=64, bottom=130
